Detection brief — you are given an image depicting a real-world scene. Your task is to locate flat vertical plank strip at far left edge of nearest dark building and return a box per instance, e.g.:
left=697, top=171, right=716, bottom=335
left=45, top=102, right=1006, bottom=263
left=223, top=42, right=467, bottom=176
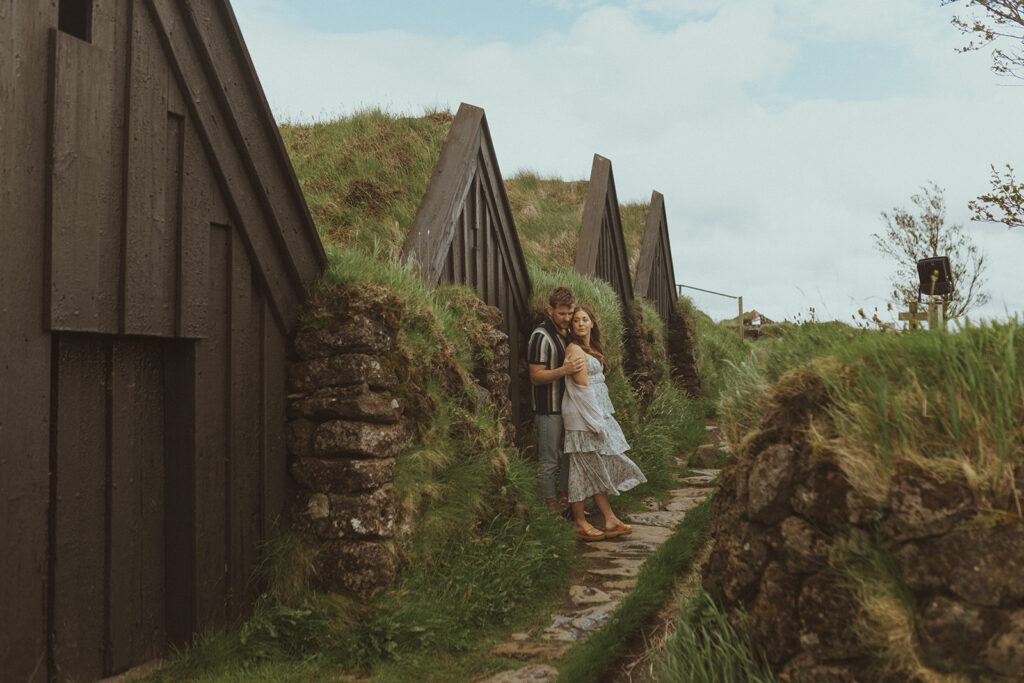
left=0, top=0, right=57, bottom=681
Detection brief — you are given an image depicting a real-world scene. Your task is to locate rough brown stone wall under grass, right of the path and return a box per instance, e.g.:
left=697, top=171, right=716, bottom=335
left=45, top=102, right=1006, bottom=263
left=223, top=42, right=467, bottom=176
left=703, top=370, right=1024, bottom=681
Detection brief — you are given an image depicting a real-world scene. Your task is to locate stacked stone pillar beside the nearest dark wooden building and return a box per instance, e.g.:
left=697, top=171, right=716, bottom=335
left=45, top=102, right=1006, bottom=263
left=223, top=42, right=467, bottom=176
left=288, top=314, right=415, bottom=597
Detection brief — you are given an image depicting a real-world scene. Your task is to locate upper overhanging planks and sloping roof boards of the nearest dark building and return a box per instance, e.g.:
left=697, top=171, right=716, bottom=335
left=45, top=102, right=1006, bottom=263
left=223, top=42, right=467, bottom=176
left=47, top=0, right=327, bottom=338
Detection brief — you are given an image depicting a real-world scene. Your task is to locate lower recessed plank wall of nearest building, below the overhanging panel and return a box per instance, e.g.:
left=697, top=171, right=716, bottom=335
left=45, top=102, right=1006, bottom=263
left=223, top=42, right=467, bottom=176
left=37, top=225, right=286, bottom=678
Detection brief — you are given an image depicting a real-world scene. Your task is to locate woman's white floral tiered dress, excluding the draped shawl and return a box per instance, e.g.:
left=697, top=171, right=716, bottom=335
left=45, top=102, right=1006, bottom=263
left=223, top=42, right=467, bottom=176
left=562, top=354, right=647, bottom=503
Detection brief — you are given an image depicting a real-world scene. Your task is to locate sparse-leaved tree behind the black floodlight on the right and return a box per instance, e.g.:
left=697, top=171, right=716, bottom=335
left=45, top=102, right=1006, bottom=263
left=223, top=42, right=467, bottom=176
left=871, top=181, right=988, bottom=317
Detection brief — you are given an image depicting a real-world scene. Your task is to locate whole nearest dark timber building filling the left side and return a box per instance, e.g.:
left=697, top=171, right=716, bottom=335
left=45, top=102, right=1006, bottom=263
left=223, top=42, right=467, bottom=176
left=0, top=0, right=326, bottom=681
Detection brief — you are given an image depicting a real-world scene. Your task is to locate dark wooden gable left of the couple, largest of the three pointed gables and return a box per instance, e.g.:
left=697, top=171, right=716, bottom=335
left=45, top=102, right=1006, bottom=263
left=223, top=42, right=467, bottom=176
left=401, top=103, right=530, bottom=424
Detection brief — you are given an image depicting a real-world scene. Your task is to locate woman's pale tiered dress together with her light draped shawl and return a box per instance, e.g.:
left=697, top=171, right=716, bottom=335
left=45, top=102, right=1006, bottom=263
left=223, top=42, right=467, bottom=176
left=562, top=354, right=647, bottom=503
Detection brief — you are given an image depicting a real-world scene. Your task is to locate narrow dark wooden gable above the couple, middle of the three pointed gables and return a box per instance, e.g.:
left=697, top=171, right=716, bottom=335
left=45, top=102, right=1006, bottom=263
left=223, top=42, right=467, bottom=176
left=575, top=155, right=633, bottom=304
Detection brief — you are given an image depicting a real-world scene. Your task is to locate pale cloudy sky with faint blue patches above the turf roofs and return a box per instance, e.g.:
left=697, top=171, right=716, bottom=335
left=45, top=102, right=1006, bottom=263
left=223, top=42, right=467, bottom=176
left=232, top=0, right=1024, bottom=323
